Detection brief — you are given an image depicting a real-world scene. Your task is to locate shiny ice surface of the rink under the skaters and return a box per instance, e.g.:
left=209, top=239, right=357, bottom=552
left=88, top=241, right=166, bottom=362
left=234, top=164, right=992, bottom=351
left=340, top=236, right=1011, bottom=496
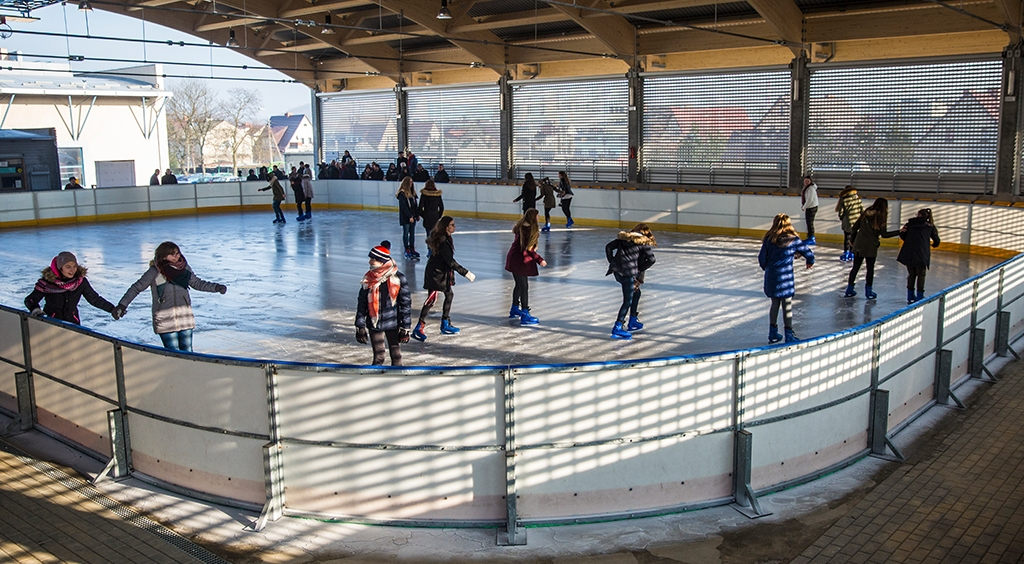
left=0, top=209, right=1000, bottom=365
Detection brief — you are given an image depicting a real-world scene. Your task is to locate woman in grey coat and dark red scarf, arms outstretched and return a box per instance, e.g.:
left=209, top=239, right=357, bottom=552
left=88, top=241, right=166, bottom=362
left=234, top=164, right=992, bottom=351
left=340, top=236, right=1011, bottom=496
left=115, top=241, right=227, bottom=352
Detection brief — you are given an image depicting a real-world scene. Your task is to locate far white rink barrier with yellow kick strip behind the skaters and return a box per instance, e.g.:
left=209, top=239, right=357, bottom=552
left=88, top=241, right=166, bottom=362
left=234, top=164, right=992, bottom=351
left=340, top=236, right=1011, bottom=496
left=0, top=180, right=1024, bottom=258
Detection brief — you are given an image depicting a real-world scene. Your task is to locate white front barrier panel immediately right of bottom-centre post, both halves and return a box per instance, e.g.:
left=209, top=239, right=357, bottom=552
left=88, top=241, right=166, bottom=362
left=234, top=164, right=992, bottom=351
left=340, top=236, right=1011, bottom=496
left=515, top=364, right=735, bottom=519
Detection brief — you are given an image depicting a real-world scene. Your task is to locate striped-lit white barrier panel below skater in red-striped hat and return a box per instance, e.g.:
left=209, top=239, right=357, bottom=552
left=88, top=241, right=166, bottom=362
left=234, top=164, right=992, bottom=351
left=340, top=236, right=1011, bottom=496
left=278, top=368, right=505, bottom=519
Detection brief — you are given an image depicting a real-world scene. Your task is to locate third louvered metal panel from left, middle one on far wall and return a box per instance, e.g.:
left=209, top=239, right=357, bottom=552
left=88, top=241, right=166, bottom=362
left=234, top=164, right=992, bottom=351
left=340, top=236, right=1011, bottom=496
left=512, top=78, right=629, bottom=182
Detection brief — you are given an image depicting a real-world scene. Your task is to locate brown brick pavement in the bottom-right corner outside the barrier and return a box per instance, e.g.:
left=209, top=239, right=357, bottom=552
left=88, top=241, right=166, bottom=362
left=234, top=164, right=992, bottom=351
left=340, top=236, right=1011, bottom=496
left=793, top=352, right=1024, bottom=564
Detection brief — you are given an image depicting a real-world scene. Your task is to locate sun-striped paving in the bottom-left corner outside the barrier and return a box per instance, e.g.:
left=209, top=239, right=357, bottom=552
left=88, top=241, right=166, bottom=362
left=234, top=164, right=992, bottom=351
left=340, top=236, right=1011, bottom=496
left=0, top=443, right=223, bottom=564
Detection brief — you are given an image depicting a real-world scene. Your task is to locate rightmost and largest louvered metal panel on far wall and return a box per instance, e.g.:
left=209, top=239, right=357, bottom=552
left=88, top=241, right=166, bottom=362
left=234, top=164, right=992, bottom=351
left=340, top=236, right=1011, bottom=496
left=806, top=60, right=1001, bottom=193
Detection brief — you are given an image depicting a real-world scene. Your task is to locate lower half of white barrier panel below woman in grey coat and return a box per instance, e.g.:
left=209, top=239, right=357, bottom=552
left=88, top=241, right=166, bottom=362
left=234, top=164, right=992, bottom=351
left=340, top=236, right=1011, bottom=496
left=128, top=415, right=266, bottom=505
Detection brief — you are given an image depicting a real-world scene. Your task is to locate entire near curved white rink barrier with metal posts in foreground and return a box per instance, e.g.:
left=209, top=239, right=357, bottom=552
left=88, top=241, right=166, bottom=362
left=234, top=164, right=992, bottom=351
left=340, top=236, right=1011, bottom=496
left=0, top=255, right=1024, bottom=545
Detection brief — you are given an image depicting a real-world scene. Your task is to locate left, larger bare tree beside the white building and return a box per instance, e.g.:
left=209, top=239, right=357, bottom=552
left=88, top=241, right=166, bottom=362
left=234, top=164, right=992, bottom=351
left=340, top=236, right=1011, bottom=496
left=167, top=78, right=223, bottom=172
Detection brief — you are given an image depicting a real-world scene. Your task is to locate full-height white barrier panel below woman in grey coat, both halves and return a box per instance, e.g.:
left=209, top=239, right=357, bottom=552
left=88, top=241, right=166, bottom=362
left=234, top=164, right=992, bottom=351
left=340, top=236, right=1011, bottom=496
left=122, top=347, right=269, bottom=503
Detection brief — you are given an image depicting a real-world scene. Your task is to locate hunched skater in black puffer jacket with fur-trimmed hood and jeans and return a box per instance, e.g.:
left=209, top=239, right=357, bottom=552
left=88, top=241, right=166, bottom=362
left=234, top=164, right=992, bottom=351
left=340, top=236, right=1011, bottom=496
left=604, top=223, right=657, bottom=340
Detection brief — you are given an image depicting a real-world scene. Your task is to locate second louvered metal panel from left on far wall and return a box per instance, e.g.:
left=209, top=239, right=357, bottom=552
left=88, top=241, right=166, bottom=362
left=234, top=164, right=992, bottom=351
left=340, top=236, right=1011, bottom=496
left=406, top=85, right=502, bottom=178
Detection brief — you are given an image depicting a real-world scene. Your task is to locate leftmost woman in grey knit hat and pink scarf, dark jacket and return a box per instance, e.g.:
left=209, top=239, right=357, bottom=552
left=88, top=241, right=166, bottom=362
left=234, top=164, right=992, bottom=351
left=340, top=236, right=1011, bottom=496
left=25, top=251, right=120, bottom=324
